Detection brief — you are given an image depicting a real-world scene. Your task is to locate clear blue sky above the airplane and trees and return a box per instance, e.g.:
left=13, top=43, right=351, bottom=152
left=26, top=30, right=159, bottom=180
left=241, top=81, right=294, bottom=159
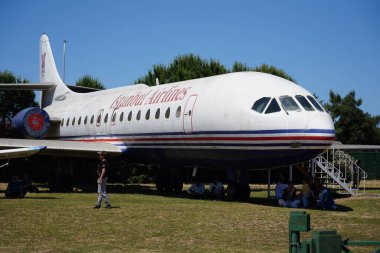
left=0, top=0, right=380, bottom=115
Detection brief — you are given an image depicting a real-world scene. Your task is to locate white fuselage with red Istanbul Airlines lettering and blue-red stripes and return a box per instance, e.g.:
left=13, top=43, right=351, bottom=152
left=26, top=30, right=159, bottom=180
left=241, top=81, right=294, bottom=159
left=44, top=72, right=335, bottom=168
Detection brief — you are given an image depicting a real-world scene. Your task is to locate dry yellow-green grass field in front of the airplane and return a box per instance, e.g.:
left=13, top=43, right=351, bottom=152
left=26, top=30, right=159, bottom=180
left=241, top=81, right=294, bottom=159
left=0, top=181, right=380, bottom=253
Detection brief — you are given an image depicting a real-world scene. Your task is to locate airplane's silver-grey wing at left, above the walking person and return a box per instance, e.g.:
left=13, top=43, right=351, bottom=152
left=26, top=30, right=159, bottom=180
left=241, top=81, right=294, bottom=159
left=0, top=138, right=123, bottom=158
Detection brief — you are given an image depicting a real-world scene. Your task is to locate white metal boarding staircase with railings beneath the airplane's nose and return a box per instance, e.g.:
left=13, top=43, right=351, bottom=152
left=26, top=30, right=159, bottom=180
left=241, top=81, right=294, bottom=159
left=311, top=149, right=368, bottom=196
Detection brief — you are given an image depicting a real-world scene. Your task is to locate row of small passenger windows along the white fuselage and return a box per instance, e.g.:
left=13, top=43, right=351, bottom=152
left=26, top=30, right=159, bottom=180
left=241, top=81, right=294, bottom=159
left=61, top=106, right=182, bottom=126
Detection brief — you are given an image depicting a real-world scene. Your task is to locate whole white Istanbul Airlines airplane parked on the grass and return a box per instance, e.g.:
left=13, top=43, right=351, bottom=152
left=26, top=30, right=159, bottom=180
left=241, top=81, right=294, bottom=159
left=0, top=34, right=335, bottom=198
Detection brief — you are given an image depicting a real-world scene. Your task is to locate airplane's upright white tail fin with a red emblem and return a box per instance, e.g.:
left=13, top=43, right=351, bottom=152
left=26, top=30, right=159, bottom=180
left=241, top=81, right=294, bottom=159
left=40, top=34, right=73, bottom=107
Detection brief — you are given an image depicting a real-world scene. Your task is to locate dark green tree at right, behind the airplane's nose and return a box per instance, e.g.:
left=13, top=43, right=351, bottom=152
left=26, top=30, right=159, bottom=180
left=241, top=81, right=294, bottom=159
left=325, top=91, right=380, bottom=144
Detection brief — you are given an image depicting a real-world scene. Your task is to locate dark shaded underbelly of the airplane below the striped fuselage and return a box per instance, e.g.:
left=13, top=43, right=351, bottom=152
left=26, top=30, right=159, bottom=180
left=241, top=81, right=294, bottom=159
left=128, top=148, right=324, bottom=169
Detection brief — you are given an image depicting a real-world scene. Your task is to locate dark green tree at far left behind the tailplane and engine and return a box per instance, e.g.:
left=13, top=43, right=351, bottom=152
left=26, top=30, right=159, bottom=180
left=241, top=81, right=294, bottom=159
left=0, top=70, right=38, bottom=137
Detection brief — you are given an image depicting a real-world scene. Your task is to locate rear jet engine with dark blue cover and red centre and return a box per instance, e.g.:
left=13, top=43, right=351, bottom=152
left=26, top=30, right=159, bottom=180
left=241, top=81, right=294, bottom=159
left=11, top=107, right=50, bottom=139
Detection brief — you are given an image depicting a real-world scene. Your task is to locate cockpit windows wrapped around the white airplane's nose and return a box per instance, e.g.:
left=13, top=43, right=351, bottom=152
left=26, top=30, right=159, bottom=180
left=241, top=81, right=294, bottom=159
left=252, top=95, right=324, bottom=114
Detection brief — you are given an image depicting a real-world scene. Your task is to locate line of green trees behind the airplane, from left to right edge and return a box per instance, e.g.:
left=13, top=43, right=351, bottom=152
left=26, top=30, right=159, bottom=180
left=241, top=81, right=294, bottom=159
left=0, top=54, right=380, bottom=145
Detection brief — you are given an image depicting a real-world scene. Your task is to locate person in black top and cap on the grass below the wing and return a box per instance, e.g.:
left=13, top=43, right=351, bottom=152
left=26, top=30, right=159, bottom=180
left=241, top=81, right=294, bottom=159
left=94, top=151, right=111, bottom=209
